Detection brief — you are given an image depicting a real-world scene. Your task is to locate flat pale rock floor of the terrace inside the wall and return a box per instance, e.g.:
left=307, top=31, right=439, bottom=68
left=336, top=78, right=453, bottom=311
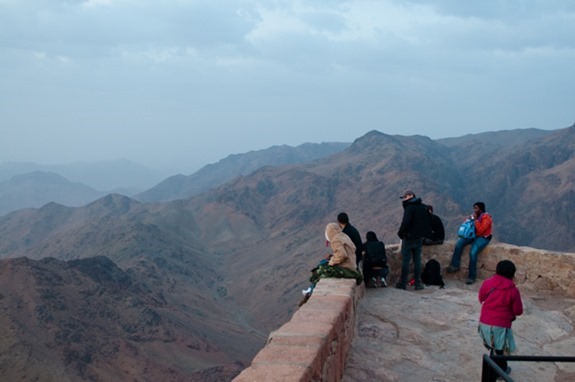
left=343, top=279, right=575, bottom=382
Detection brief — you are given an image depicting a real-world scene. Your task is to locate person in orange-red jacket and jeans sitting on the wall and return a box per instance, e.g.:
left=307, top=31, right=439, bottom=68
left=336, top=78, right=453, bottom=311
left=446, top=202, right=493, bottom=285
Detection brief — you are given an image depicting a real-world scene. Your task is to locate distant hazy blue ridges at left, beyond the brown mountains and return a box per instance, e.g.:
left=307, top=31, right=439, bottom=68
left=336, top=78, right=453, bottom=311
left=0, top=142, right=350, bottom=216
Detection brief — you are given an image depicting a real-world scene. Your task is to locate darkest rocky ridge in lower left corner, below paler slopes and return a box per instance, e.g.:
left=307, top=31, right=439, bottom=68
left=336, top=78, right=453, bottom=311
left=0, top=256, right=254, bottom=381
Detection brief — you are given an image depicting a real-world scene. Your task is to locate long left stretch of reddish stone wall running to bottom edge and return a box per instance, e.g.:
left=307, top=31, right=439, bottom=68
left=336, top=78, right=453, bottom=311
left=234, top=279, right=365, bottom=382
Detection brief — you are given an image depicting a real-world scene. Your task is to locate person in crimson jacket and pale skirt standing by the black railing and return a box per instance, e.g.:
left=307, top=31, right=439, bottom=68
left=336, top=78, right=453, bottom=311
left=478, top=260, right=523, bottom=374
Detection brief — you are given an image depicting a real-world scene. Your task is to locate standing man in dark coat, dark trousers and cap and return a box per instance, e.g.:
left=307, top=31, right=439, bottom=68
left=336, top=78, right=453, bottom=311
left=395, top=190, right=431, bottom=290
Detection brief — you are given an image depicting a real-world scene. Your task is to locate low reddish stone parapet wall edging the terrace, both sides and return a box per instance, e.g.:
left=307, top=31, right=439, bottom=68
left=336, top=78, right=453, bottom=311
left=234, top=242, right=575, bottom=382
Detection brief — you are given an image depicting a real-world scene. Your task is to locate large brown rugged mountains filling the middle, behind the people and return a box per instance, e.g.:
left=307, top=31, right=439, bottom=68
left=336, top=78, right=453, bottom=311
left=0, top=125, right=575, bottom=381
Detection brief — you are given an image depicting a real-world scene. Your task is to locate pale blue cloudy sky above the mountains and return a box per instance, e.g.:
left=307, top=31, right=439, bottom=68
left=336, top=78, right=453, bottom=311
left=0, top=0, right=575, bottom=174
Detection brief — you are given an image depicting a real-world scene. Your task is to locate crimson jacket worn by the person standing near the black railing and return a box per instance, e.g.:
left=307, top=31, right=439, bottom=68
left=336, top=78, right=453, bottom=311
left=478, top=274, right=523, bottom=328
